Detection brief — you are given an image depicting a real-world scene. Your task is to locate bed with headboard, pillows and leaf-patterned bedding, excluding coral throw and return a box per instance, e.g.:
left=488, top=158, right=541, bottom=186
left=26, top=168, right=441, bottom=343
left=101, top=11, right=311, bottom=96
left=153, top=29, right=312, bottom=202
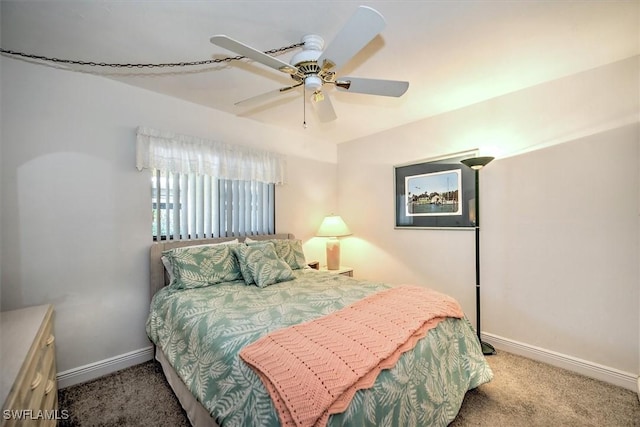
left=146, top=234, right=493, bottom=427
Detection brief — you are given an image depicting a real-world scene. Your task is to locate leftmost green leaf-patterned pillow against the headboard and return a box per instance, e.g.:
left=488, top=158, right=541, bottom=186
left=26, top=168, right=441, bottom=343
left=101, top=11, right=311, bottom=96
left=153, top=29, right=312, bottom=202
left=162, top=245, right=242, bottom=289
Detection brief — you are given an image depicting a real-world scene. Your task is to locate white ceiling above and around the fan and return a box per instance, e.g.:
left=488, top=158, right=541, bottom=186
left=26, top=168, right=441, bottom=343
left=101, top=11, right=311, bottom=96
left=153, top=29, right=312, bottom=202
left=0, top=0, right=640, bottom=143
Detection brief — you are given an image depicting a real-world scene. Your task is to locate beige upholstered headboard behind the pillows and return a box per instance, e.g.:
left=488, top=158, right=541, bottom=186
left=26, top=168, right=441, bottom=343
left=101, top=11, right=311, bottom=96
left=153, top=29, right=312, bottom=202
left=149, top=233, right=295, bottom=297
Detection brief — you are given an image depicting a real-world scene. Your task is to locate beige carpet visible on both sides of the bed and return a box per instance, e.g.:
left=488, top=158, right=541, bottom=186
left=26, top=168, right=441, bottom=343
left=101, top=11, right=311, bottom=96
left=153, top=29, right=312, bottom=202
left=59, top=352, right=640, bottom=427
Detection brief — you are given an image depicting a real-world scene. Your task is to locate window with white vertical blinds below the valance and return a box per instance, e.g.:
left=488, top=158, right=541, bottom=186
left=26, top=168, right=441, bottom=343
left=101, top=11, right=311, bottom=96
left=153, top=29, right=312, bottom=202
left=151, top=169, right=275, bottom=240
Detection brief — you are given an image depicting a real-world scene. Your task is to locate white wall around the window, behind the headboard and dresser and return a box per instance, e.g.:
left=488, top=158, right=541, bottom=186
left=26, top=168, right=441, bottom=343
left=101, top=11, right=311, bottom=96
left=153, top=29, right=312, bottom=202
left=0, top=58, right=337, bottom=371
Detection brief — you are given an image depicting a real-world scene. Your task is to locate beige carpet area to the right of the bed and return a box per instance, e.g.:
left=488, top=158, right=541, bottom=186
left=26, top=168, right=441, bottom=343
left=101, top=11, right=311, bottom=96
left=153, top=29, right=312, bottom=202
left=451, top=352, right=640, bottom=427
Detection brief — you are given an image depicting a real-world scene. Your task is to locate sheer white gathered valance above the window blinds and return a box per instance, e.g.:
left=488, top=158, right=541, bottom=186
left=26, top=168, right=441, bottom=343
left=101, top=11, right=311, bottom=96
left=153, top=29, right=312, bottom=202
left=136, top=127, right=286, bottom=184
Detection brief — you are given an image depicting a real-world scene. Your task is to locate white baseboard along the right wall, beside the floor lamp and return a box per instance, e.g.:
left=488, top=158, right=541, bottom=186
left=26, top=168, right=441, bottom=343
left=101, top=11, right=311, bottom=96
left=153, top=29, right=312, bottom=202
left=482, top=333, right=640, bottom=392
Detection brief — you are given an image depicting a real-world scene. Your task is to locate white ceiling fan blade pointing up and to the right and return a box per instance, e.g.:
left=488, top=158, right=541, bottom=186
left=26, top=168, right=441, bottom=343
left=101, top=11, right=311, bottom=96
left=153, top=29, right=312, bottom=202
left=318, top=6, right=386, bottom=70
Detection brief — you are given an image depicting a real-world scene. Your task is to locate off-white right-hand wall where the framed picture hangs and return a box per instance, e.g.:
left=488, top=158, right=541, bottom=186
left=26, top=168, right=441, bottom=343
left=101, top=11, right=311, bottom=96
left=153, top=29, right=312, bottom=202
left=338, top=57, right=640, bottom=382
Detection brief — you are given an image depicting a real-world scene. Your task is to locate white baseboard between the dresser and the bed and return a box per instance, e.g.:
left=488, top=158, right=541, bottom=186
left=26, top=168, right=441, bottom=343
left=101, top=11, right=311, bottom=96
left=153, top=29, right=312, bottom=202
left=57, top=346, right=153, bottom=389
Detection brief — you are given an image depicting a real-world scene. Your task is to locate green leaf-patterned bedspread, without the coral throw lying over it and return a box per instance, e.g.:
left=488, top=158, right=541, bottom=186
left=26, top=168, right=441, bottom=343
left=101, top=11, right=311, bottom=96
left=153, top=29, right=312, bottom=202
left=146, top=269, right=493, bottom=427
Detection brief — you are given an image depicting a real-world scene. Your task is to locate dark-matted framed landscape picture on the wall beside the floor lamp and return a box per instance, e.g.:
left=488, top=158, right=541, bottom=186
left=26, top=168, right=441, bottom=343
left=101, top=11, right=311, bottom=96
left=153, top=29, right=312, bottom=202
left=393, top=150, right=478, bottom=229
